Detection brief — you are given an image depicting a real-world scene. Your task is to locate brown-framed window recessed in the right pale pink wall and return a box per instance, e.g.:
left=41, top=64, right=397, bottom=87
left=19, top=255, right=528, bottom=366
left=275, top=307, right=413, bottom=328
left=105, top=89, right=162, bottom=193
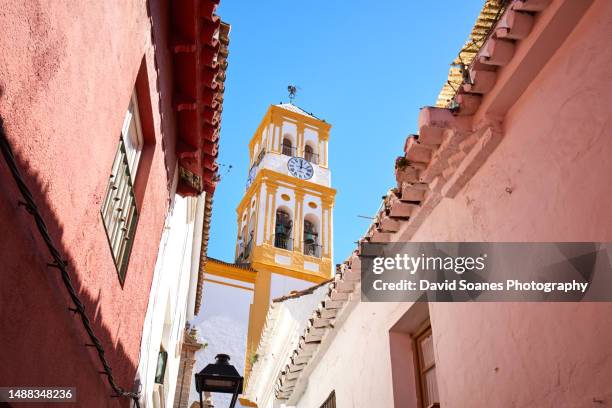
left=414, top=322, right=440, bottom=408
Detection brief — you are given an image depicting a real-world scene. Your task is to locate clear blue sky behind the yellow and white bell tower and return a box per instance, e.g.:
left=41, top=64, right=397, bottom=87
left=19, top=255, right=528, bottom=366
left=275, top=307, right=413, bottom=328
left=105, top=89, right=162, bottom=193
left=194, top=0, right=484, bottom=402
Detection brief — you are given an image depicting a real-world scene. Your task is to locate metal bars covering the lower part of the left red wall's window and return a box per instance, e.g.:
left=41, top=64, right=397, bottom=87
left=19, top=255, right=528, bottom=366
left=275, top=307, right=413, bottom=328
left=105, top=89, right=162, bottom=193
left=100, top=137, right=138, bottom=285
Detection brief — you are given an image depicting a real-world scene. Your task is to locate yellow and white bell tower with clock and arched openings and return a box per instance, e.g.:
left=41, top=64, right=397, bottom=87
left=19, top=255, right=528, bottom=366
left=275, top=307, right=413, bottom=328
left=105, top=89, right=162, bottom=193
left=235, top=103, right=336, bottom=380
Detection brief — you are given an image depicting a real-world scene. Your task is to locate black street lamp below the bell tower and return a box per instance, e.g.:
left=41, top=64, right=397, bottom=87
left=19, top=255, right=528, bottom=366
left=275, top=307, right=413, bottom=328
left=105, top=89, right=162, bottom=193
left=195, top=354, right=243, bottom=408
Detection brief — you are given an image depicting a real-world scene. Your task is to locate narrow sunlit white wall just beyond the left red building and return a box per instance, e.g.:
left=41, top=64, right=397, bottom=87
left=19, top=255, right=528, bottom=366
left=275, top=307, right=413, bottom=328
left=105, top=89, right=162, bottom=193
left=136, top=194, right=205, bottom=407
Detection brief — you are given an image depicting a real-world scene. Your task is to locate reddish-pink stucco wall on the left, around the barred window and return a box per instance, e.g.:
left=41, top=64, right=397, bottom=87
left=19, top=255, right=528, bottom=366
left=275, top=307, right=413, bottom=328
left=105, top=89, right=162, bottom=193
left=0, top=0, right=176, bottom=407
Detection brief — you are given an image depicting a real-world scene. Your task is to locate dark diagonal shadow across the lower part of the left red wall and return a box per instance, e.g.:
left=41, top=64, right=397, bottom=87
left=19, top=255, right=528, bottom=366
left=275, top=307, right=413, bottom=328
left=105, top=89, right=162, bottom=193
left=0, top=118, right=139, bottom=407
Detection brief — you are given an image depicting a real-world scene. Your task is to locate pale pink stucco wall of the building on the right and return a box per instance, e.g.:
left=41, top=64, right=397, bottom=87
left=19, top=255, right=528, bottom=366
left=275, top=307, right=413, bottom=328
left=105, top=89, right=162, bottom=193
left=297, top=0, right=612, bottom=408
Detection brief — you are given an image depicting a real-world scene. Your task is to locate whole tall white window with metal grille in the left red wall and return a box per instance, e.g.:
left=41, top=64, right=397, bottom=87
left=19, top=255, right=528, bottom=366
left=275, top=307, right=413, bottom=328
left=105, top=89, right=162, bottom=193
left=100, top=93, right=143, bottom=285
